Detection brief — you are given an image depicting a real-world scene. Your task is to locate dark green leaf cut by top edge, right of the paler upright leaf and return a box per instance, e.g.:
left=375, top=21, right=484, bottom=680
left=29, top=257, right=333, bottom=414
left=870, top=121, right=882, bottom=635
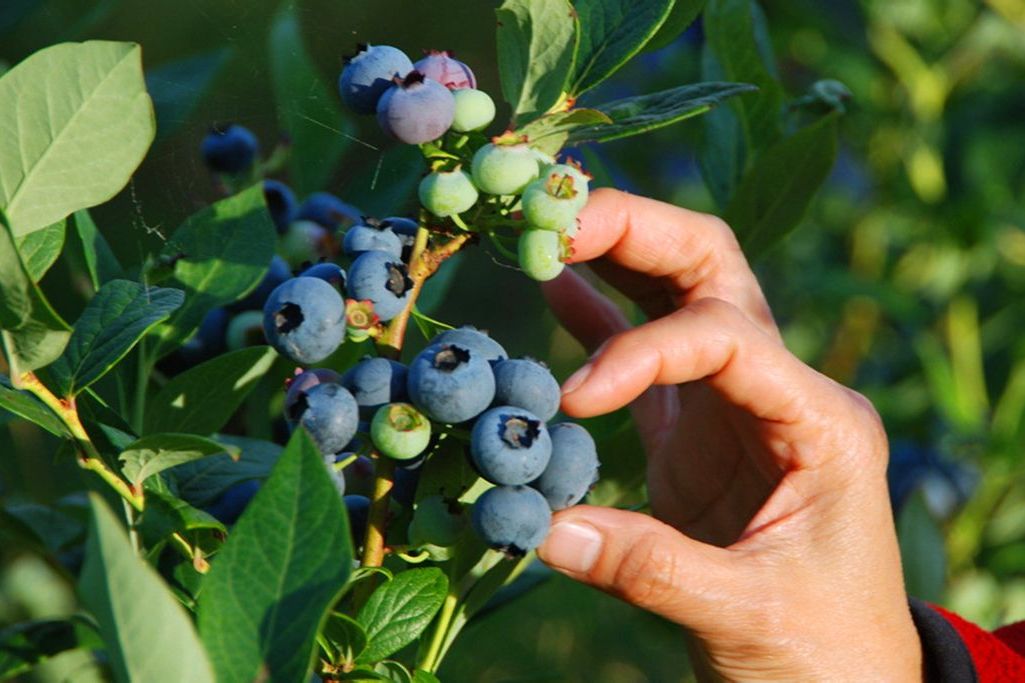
left=570, top=0, right=673, bottom=96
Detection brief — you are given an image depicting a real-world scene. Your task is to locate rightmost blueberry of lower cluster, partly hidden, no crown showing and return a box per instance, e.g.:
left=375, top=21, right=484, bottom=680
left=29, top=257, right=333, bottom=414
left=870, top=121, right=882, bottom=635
left=531, top=423, right=600, bottom=510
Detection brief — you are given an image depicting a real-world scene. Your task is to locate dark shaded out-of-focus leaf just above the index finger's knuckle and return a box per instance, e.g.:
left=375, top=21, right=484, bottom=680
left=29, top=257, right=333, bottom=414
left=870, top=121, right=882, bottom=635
left=724, top=114, right=837, bottom=260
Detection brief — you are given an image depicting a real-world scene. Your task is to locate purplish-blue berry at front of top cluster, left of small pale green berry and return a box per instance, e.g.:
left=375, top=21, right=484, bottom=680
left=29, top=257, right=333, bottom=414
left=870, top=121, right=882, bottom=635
left=377, top=71, right=455, bottom=145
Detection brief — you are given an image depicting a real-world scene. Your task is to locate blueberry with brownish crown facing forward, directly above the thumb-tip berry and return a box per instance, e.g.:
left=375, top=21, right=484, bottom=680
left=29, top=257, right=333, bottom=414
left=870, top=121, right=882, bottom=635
left=469, top=405, right=551, bottom=486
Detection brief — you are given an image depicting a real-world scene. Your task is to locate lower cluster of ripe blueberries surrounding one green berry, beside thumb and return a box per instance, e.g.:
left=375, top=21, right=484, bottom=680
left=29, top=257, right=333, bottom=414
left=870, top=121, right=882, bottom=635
left=276, top=319, right=599, bottom=555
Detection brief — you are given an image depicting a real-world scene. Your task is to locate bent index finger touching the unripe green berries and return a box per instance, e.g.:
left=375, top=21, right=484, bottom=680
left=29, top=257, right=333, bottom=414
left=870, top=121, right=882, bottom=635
left=570, top=189, right=778, bottom=334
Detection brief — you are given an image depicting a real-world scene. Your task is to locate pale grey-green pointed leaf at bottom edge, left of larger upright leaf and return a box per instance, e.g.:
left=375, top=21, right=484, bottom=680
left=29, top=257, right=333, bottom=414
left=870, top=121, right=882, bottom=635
left=78, top=493, right=214, bottom=683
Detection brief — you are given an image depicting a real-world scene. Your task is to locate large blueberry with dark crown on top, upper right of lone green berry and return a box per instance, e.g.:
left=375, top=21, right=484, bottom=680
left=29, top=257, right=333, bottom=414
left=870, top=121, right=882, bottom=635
left=408, top=344, right=495, bottom=424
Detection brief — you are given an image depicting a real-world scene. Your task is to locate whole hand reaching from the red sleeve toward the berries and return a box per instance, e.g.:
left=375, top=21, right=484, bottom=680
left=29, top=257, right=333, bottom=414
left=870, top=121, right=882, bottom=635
left=538, top=190, right=921, bottom=681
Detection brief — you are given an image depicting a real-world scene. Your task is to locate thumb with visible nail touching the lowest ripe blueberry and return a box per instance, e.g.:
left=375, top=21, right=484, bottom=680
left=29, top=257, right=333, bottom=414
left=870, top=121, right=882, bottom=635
left=537, top=506, right=744, bottom=631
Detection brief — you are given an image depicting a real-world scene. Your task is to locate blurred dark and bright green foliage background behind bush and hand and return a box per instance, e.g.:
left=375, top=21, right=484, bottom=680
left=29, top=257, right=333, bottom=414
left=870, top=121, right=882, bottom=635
left=6, top=0, right=1025, bottom=681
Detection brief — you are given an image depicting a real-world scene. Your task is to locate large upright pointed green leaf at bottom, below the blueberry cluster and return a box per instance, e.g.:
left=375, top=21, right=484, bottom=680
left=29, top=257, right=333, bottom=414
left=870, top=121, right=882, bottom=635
left=199, top=430, right=353, bottom=683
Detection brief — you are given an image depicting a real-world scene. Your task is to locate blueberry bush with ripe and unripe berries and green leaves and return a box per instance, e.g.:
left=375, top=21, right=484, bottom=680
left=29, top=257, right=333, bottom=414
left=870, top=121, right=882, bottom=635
left=0, top=0, right=842, bottom=682
